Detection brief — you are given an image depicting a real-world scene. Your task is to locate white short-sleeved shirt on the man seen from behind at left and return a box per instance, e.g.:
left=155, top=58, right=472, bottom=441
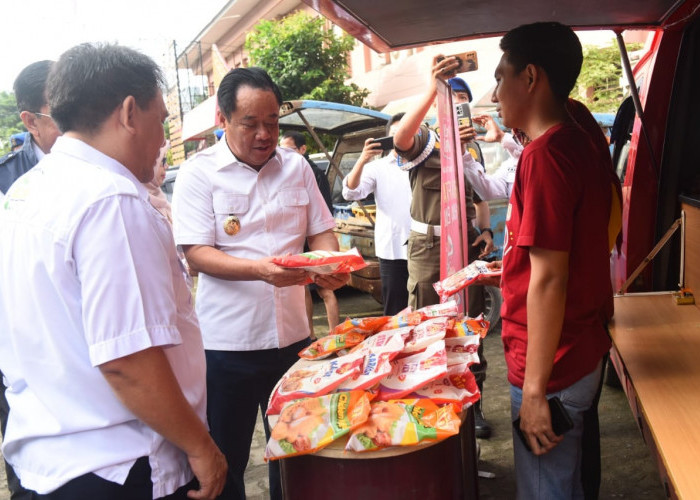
left=0, top=136, right=206, bottom=498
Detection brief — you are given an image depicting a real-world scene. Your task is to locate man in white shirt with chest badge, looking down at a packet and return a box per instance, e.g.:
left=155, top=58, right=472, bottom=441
left=173, top=68, right=349, bottom=499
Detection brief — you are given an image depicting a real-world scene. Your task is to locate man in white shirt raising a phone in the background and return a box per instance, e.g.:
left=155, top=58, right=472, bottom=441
left=343, top=113, right=411, bottom=316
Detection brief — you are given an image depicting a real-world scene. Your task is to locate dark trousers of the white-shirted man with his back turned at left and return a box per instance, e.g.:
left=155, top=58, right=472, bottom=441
left=33, top=457, right=199, bottom=500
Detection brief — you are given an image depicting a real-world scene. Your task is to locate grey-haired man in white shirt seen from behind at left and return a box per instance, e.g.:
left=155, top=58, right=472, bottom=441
left=0, top=44, right=227, bottom=500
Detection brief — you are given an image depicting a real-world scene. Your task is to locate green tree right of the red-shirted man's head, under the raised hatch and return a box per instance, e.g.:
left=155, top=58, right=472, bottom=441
left=571, top=44, right=640, bottom=113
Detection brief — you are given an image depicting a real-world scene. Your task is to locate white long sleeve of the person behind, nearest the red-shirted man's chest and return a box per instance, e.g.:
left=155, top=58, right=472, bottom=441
left=462, top=134, right=523, bottom=201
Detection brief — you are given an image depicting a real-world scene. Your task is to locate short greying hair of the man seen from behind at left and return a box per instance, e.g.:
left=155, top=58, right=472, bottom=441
left=47, top=43, right=165, bottom=133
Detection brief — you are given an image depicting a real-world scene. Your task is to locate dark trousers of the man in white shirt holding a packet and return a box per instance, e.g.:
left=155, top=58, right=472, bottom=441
left=205, top=338, right=310, bottom=500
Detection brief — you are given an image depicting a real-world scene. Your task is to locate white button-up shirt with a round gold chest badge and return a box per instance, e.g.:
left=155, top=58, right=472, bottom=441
left=173, top=140, right=335, bottom=351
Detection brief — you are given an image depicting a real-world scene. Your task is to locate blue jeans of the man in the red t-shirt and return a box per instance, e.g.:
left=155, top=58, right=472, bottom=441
left=510, top=363, right=601, bottom=500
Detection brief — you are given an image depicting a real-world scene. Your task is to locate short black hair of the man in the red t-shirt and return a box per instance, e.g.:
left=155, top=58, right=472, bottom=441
left=500, top=22, right=583, bottom=101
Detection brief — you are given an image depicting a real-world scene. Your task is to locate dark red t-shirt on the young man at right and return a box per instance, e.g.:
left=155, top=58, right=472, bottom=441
left=501, top=123, right=612, bottom=393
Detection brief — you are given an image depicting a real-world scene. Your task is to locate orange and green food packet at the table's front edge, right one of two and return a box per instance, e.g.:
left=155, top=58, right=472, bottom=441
left=345, top=399, right=461, bottom=451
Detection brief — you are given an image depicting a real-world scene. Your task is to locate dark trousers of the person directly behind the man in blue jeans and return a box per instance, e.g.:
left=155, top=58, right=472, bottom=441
left=581, top=354, right=610, bottom=500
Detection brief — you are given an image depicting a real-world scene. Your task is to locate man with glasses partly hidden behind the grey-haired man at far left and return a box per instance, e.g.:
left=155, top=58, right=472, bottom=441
left=0, top=61, right=61, bottom=193
